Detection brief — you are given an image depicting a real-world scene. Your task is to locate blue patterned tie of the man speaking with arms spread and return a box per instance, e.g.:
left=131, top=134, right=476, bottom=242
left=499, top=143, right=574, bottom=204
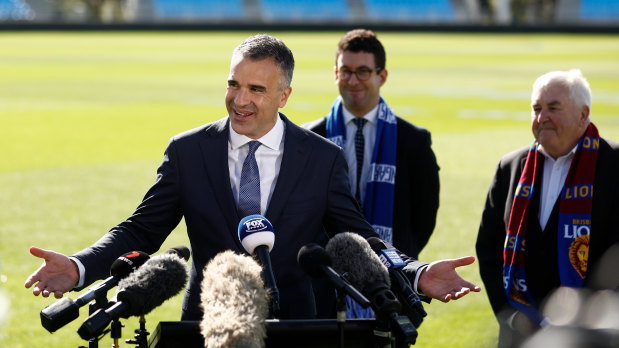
left=239, top=140, right=261, bottom=217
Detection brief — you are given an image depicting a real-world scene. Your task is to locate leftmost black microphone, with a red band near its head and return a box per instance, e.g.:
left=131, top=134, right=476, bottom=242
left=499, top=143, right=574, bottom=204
left=40, top=251, right=150, bottom=332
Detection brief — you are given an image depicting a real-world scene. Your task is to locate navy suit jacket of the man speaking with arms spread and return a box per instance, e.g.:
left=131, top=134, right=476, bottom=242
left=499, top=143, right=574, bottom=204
left=74, top=114, right=390, bottom=320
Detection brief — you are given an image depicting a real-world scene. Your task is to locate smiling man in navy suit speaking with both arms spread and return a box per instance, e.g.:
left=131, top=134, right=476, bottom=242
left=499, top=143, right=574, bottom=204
left=25, top=35, right=480, bottom=320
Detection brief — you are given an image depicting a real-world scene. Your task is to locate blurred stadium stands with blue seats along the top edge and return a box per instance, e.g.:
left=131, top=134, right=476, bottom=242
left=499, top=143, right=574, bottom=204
left=0, top=0, right=619, bottom=30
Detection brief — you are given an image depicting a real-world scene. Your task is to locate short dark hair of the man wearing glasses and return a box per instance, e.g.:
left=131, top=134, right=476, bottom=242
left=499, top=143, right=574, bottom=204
left=335, top=29, right=387, bottom=69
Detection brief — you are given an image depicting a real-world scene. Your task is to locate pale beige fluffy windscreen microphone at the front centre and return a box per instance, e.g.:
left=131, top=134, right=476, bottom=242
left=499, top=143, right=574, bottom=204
left=200, top=251, right=269, bottom=348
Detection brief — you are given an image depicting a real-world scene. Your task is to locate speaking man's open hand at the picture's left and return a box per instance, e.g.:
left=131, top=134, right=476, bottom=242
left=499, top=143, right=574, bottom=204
left=24, top=247, right=79, bottom=298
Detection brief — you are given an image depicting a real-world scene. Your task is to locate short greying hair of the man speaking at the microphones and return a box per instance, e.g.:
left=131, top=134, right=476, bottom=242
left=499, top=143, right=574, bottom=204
left=232, top=34, right=294, bottom=88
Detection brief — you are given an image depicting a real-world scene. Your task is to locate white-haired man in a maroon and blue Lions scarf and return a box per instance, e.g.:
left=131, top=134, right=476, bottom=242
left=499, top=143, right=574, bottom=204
left=476, top=70, right=619, bottom=347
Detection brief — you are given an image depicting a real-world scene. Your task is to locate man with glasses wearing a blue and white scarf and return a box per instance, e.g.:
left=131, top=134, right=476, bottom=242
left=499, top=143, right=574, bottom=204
left=304, top=29, right=439, bottom=318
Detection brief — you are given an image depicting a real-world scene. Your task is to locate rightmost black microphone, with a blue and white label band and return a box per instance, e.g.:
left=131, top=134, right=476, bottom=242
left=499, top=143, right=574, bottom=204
left=367, top=237, right=427, bottom=327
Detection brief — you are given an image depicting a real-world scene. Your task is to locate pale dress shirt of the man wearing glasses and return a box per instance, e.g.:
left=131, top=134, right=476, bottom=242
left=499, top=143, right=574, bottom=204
left=342, top=104, right=378, bottom=202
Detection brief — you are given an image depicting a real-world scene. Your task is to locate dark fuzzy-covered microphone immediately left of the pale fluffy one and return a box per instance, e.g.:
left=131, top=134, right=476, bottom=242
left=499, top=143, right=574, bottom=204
left=77, top=247, right=187, bottom=340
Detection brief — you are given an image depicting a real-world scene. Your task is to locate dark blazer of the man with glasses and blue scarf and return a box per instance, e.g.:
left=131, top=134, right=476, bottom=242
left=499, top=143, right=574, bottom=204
left=303, top=117, right=440, bottom=258
